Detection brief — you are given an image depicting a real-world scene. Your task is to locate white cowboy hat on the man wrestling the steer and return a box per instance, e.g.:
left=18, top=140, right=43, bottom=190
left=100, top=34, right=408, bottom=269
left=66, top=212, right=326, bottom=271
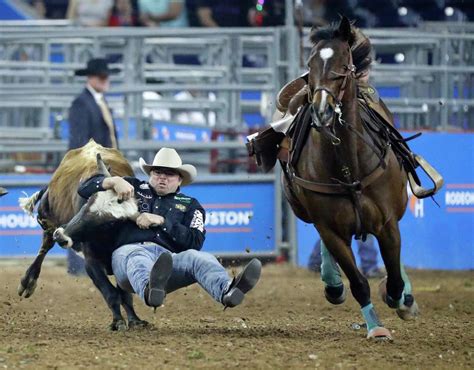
left=138, top=148, right=197, bottom=186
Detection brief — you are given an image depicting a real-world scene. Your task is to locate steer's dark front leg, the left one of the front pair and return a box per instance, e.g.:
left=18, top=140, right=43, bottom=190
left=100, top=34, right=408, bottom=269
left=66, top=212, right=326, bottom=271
left=84, top=253, right=127, bottom=331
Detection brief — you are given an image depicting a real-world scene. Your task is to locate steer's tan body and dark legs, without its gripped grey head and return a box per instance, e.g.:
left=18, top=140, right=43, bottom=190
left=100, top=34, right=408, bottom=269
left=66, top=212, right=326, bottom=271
left=18, top=140, right=148, bottom=330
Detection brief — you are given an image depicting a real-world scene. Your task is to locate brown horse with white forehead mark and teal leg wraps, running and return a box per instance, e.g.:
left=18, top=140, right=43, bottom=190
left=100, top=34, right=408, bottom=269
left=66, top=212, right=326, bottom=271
left=282, top=17, right=418, bottom=339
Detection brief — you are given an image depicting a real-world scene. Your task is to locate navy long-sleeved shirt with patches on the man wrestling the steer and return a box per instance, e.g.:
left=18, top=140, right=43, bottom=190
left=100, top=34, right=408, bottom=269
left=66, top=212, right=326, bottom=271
left=78, top=175, right=206, bottom=253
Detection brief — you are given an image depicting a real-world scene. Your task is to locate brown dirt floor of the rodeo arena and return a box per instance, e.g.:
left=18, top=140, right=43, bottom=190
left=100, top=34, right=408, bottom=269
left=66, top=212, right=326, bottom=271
left=0, top=263, right=474, bottom=369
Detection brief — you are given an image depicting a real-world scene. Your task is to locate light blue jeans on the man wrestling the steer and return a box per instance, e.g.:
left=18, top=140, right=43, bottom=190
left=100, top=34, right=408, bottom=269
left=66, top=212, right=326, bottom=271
left=112, top=244, right=232, bottom=302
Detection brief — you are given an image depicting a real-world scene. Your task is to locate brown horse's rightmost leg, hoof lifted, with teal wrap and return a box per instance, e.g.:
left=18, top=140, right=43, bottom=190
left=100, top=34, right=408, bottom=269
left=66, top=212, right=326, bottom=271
left=377, top=222, right=419, bottom=320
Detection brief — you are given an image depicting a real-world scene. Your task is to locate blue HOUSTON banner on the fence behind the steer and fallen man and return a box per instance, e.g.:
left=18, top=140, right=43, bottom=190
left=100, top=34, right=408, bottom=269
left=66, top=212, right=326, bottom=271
left=0, top=181, right=275, bottom=257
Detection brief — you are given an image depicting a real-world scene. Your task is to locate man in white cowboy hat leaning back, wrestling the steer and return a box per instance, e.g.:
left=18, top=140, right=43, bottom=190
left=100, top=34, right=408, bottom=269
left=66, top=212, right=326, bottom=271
left=79, top=148, right=261, bottom=307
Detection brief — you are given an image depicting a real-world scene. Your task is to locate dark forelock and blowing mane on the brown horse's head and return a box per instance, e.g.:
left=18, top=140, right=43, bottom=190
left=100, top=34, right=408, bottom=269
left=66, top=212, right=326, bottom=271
left=309, top=23, right=372, bottom=74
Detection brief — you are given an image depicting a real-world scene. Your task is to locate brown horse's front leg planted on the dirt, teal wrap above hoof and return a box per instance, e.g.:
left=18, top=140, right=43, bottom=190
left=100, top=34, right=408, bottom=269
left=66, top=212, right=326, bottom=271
left=321, top=229, right=392, bottom=340
